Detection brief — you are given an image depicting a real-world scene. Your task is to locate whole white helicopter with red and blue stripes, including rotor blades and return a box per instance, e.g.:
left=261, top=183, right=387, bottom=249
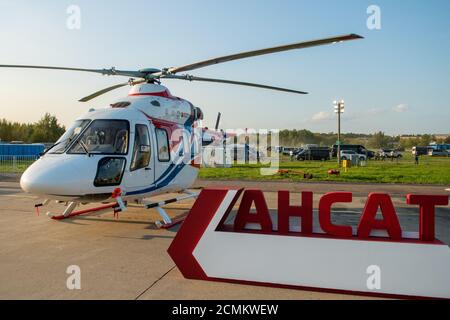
left=0, top=34, right=363, bottom=227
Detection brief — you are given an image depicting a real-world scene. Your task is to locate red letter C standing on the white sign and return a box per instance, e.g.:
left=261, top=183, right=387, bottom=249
left=319, top=192, right=353, bottom=237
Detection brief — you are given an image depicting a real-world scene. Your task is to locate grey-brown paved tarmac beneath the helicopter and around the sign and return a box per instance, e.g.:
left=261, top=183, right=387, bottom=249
left=0, top=179, right=450, bottom=300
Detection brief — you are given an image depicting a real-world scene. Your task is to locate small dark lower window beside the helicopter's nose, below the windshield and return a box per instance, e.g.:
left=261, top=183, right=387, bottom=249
left=94, top=157, right=126, bottom=187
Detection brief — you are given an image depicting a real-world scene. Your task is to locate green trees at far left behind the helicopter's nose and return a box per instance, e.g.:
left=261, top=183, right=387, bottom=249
left=0, top=113, right=66, bottom=143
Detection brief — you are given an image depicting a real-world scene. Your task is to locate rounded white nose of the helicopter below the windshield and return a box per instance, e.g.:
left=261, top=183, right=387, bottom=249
left=20, top=157, right=91, bottom=196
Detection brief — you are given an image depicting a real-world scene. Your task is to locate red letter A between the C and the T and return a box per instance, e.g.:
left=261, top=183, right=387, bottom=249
left=358, top=193, right=402, bottom=240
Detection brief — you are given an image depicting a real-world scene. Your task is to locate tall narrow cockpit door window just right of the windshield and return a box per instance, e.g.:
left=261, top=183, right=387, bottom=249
left=127, top=123, right=155, bottom=188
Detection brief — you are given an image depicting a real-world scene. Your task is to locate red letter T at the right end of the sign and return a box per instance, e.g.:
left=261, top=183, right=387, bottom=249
left=406, top=194, right=448, bottom=241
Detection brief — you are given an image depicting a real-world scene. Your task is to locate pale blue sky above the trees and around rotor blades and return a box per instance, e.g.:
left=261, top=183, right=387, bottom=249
left=0, top=0, right=450, bottom=134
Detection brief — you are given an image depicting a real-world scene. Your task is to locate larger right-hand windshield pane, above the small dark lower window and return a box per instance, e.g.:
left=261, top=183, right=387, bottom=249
left=69, top=120, right=130, bottom=155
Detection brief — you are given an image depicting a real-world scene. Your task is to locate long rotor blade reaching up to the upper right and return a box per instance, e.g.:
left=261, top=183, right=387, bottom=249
left=167, top=33, right=363, bottom=74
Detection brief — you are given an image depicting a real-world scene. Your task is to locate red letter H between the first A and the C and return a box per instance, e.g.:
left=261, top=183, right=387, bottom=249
left=278, top=191, right=313, bottom=234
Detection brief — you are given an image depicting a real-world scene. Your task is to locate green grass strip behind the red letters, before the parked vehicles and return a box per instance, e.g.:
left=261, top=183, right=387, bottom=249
left=200, top=154, right=450, bottom=185
